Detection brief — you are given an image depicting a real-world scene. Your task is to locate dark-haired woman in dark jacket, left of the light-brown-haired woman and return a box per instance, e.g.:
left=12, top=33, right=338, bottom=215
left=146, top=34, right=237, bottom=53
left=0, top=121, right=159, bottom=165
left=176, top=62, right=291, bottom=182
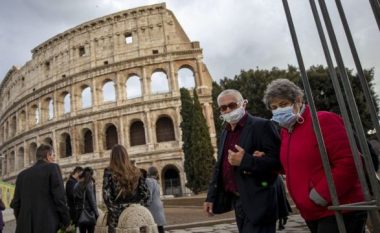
left=74, top=167, right=99, bottom=233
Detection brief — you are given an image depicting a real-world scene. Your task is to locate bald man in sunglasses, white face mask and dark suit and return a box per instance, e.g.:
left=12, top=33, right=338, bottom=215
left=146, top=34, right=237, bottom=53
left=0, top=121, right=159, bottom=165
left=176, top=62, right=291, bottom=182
left=204, top=89, right=281, bottom=233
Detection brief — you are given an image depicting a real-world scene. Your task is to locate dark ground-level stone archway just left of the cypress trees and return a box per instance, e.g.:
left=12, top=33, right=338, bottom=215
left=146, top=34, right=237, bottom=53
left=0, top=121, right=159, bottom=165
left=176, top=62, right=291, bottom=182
left=161, top=164, right=182, bottom=196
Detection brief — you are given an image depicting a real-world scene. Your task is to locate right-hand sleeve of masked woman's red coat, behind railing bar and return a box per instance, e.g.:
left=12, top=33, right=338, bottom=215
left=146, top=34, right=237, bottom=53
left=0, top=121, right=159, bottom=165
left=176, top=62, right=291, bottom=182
left=315, top=112, right=357, bottom=203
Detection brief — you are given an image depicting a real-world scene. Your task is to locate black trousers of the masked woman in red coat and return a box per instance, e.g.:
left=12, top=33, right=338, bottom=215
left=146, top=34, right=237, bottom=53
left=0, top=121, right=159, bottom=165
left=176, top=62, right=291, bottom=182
left=306, top=211, right=367, bottom=233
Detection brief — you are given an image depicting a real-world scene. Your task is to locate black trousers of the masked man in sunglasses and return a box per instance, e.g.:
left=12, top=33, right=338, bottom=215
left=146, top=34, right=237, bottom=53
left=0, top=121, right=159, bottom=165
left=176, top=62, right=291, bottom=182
left=233, top=197, right=276, bottom=233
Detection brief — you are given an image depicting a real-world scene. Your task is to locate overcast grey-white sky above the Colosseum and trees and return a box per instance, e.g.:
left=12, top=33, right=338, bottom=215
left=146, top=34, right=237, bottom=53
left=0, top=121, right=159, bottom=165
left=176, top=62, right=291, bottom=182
left=0, top=0, right=380, bottom=94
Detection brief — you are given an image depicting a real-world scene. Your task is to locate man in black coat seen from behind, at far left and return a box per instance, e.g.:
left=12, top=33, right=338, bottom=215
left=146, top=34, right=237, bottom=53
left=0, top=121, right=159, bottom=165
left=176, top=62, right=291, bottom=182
left=11, top=144, right=70, bottom=233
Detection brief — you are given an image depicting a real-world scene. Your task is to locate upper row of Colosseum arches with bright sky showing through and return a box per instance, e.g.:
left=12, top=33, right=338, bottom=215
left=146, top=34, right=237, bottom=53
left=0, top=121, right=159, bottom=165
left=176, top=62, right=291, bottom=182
left=0, top=66, right=195, bottom=142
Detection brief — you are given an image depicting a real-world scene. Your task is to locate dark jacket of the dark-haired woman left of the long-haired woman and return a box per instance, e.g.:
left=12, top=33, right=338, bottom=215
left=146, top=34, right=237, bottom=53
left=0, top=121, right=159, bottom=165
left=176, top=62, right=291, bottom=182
left=74, top=181, right=99, bottom=222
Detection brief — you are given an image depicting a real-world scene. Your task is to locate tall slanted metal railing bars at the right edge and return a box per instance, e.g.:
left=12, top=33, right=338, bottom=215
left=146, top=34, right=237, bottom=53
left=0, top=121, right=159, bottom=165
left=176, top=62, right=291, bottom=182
left=282, top=0, right=380, bottom=233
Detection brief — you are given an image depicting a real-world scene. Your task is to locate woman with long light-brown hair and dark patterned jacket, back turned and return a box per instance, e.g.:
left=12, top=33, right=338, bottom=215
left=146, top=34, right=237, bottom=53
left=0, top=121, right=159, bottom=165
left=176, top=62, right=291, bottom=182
left=103, top=145, right=150, bottom=233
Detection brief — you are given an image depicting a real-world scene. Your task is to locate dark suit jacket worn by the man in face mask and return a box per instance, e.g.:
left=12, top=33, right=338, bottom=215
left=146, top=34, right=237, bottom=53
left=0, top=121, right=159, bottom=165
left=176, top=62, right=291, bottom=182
left=206, top=114, right=281, bottom=224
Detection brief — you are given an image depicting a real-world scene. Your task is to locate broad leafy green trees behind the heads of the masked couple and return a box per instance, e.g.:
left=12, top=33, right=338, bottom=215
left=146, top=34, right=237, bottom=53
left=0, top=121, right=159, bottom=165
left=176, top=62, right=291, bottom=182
left=213, top=65, right=378, bottom=136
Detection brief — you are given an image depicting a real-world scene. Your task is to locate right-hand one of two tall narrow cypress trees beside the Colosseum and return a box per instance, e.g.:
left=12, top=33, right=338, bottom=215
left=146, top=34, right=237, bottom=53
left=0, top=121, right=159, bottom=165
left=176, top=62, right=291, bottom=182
left=185, top=89, right=215, bottom=194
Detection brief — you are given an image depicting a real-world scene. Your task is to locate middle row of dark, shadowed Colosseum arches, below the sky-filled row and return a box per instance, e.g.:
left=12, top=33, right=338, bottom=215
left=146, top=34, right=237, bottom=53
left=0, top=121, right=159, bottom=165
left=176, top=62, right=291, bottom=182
left=3, top=116, right=176, bottom=173
